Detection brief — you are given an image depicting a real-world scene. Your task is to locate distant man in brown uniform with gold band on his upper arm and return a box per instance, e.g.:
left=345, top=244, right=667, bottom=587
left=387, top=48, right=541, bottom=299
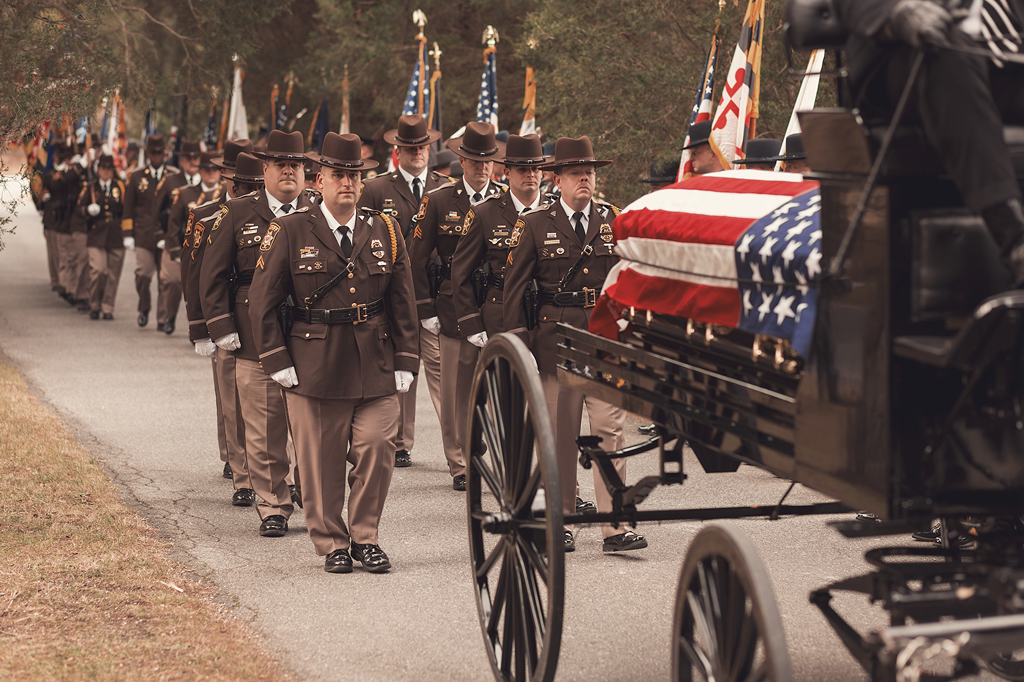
left=121, top=135, right=180, bottom=331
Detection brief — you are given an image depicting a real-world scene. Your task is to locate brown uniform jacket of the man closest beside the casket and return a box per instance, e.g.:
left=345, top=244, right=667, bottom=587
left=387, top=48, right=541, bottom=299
left=505, top=200, right=618, bottom=374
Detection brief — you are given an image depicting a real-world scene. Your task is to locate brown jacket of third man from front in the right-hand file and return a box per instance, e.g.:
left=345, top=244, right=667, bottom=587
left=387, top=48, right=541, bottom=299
left=409, top=181, right=504, bottom=338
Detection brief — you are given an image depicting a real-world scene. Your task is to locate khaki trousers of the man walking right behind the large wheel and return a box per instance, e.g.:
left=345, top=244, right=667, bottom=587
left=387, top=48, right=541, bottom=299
left=541, top=372, right=626, bottom=538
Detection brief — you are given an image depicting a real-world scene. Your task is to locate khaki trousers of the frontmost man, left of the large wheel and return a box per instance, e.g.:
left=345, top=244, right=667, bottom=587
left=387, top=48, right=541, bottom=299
left=286, top=391, right=398, bottom=556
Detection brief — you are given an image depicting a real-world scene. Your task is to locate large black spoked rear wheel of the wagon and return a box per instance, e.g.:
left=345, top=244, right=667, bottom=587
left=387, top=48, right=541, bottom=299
left=465, top=334, right=565, bottom=682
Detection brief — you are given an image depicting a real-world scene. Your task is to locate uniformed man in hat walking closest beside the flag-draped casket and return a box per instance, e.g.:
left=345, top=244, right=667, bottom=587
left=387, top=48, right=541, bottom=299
left=505, top=136, right=647, bottom=552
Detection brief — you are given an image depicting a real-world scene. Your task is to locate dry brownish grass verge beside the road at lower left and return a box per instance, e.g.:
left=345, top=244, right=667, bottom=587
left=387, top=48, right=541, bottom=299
left=0, top=363, right=294, bottom=682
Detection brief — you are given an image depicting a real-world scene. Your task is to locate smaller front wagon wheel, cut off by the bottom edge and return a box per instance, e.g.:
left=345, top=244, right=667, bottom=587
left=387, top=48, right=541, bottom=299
left=672, top=526, right=792, bottom=682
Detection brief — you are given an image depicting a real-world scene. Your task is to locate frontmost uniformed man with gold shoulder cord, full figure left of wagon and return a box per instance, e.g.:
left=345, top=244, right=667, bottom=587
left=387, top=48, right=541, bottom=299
left=245, top=132, right=419, bottom=573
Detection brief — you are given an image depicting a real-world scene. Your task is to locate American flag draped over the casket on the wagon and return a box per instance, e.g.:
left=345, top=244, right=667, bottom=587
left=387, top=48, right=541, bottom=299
left=591, top=170, right=821, bottom=356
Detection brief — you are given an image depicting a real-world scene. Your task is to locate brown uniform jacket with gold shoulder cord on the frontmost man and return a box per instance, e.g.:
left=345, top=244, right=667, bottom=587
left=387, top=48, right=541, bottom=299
left=250, top=206, right=420, bottom=399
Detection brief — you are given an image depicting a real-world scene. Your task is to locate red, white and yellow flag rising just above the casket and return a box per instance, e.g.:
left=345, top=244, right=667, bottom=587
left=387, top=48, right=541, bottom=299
left=711, top=0, right=765, bottom=169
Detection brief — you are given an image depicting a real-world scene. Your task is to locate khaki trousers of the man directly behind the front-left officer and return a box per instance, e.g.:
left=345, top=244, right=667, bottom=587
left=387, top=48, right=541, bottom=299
left=234, top=357, right=293, bottom=519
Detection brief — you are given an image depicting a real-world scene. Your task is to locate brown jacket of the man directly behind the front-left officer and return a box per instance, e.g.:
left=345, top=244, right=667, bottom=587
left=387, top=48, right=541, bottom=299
left=193, top=187, right=310, bottom=360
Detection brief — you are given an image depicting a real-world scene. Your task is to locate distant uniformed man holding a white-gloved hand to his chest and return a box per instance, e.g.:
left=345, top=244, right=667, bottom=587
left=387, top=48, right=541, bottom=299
left=77, top=155, right=125, bottom=319
